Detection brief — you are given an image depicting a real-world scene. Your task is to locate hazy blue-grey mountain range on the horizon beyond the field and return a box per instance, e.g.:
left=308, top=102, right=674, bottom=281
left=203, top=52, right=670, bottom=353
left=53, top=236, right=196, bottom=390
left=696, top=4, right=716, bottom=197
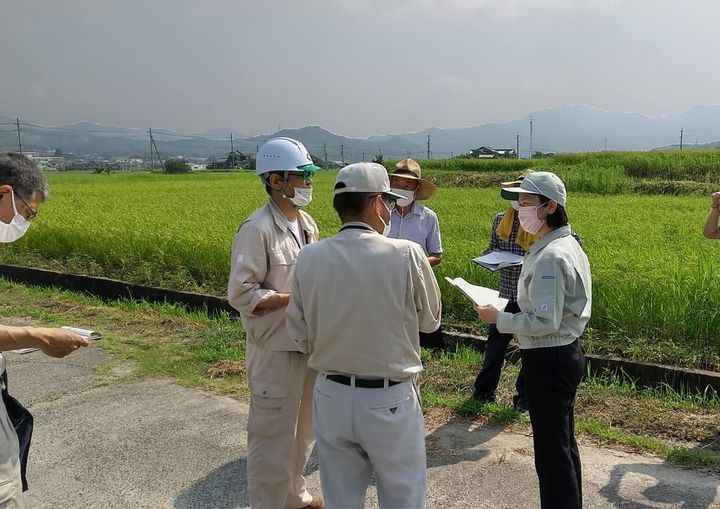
left=0, top=105, right=720, bottom=161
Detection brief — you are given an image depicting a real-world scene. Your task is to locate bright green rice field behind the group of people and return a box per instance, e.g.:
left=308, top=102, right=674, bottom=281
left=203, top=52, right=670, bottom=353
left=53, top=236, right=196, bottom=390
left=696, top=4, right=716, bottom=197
left=0, top=152, right=720, bottom=369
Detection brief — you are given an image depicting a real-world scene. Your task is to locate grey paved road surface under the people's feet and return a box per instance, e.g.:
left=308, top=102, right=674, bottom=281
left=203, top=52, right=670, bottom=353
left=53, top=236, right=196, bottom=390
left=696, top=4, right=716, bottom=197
left=7, top=346, right=720, bottom=509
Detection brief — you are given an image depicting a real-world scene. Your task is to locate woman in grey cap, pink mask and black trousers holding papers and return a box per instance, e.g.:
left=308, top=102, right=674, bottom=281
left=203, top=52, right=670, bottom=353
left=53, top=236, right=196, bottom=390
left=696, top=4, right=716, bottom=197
left=475, top=172, right=592, bottom=509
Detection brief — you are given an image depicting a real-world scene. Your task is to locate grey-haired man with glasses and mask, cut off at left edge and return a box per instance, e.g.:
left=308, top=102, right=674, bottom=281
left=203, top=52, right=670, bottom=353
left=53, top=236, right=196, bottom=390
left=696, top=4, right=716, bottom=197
left=0, top=152, right=88, bottom=507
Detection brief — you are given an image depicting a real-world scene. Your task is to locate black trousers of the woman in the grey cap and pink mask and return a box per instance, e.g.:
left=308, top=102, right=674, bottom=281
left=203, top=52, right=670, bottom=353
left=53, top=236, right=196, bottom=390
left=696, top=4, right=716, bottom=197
left=522, top=340, right=585, bottom=509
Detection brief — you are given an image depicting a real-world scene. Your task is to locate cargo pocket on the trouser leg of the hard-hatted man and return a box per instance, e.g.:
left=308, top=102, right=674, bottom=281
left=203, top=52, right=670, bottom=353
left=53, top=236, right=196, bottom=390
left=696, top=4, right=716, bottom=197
left=247, top=383, right=290, bottom=436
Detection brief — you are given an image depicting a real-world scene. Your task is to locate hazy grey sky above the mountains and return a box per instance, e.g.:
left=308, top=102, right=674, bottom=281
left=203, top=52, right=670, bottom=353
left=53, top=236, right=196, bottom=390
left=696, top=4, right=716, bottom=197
left=0, top=0, right=720, bottom=136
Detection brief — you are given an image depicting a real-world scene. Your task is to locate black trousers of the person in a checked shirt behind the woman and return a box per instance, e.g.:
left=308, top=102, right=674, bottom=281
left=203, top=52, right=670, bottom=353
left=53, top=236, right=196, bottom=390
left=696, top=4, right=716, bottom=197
left=473, top=301, right=526, bottom=405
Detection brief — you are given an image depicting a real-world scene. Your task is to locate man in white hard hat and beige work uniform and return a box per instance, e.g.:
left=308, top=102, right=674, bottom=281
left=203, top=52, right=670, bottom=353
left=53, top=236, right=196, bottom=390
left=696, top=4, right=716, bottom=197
left=228, top=138, right=324, bottom=509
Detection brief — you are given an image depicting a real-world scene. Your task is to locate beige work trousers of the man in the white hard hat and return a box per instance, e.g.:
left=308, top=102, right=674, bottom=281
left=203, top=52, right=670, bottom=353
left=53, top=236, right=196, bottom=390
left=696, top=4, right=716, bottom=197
left=246, top=342, right=317, bottom=509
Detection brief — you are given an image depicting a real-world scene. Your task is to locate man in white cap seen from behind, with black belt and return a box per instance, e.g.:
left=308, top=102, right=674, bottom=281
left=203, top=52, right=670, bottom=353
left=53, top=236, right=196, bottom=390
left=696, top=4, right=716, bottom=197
left=287, top=163, right=440, bottom=508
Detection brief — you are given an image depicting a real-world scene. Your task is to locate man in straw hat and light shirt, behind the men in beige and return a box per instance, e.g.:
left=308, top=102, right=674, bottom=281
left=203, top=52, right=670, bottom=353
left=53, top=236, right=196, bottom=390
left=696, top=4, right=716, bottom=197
left=388, top=159, right=444, bottom=350
